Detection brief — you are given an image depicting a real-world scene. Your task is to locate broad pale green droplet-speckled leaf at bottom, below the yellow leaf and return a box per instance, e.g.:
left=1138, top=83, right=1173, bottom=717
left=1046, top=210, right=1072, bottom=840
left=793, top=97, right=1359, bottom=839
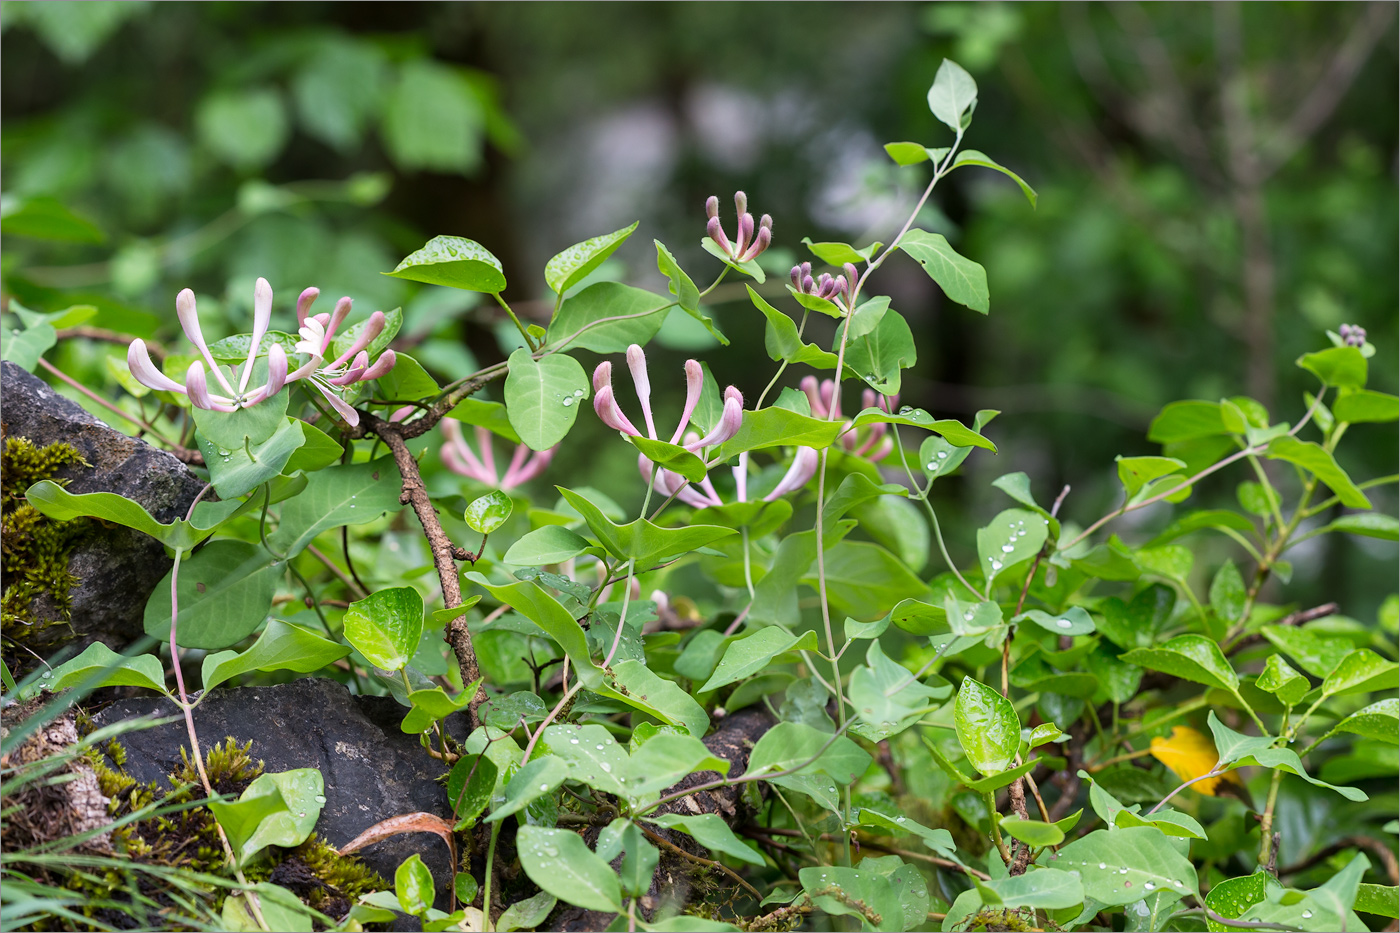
left=1058, top=827, right=1198, bottom=906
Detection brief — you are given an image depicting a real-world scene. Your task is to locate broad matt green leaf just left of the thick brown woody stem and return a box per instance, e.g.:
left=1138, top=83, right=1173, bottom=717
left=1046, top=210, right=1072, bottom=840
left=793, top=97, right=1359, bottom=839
left=267, top=457, right=402, bottom=558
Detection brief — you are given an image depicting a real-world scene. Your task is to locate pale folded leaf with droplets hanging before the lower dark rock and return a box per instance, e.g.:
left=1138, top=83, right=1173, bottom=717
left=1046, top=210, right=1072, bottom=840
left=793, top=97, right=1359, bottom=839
left=209, top=768, right=325, bottom=864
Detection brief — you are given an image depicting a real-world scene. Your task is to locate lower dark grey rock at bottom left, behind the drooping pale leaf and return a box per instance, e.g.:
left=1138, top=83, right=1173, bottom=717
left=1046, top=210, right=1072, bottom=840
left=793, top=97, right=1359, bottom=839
left=94, top=678, right=466, bottom=911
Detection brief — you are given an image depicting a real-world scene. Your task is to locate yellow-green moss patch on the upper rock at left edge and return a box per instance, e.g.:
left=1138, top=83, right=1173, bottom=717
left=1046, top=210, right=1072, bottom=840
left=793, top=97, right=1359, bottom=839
left=0, top=437, right=90, bottom=672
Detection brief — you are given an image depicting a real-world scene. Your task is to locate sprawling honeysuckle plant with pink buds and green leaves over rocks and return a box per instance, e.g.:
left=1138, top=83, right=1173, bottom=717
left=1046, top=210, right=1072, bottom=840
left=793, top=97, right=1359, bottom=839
left=7, top=62, right=1400, bottom=930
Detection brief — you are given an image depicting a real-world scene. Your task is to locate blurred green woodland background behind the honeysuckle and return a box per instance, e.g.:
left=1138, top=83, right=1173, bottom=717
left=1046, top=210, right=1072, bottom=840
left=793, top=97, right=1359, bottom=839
left=0, top=0, right=1400, bottom=622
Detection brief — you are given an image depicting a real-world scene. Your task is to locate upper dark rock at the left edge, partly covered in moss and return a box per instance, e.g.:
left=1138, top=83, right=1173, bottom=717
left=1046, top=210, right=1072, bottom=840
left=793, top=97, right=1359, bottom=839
left=0, top=355, right=204, bottom=650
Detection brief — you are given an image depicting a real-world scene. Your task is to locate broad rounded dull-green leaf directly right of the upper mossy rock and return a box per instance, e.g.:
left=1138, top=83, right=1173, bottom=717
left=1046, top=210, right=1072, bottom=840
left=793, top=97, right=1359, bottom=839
left=143, top=541, right=286, bottom=650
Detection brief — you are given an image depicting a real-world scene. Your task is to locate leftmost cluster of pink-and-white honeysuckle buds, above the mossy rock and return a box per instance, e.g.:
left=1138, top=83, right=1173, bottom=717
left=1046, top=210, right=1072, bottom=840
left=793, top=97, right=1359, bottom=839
left=126, top=279, right=398, bottom=424
